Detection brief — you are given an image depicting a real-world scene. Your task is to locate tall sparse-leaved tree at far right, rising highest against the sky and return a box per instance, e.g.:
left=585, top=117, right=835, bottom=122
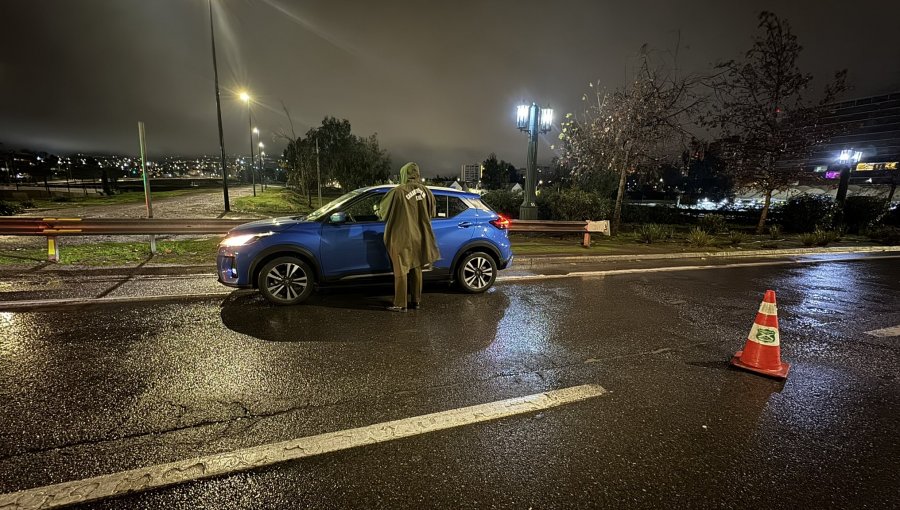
left=706, top=12, right=846, bottom=233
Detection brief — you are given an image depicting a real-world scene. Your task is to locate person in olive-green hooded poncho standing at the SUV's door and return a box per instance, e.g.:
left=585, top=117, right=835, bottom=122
left=378, top=163, right=441, bottom=312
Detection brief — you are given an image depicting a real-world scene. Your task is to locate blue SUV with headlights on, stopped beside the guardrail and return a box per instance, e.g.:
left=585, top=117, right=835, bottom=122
left=216, top=185, right=513, bottom=305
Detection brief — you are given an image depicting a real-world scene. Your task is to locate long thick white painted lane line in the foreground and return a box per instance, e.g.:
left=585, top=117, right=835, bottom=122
left=0, top=384, right=606, bottom=510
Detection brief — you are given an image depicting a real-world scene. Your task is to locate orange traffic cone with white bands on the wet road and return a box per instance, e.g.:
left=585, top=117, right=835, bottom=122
left=731, top=290, right=790, bottom=379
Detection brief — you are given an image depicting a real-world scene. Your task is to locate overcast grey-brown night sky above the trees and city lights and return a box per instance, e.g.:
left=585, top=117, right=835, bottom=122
left=0, top=0, right=900, bottom=175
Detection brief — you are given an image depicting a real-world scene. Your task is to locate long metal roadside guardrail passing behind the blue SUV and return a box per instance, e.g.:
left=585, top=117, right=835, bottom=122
left=0, top=216, right=610, bottom=262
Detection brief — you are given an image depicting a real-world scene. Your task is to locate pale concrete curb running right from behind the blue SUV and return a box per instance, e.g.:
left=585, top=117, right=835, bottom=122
left=511, top=246, right=900, bottom=269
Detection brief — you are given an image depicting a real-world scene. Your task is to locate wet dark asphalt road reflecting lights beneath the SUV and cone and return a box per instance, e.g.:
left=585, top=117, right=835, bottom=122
left=0, top=257, right=900, bottom=509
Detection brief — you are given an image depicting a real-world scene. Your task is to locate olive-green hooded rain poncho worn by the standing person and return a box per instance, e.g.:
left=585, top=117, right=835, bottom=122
left=378, top=163, right=441, bottom=274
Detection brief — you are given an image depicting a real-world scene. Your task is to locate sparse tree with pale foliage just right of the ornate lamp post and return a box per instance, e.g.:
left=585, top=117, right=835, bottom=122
left=559, top=45, right=702, bottom=233
